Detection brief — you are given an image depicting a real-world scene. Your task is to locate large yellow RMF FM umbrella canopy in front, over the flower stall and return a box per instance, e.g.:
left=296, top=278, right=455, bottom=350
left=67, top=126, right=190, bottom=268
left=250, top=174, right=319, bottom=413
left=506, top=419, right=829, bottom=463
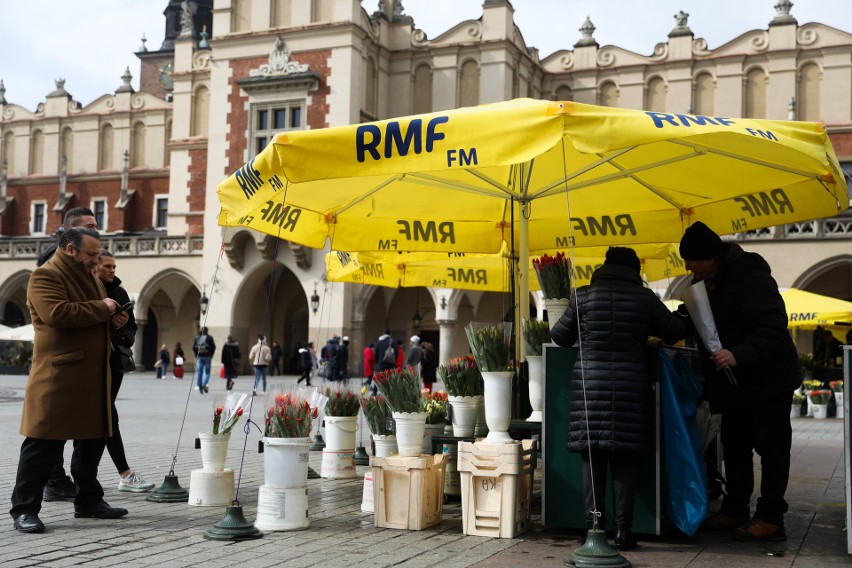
left=218, top=99, right=849, bottom=254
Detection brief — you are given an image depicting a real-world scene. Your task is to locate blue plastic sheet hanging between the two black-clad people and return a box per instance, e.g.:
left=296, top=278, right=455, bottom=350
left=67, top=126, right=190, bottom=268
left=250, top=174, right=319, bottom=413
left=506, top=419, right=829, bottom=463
left=660, top=349, right=707, bottom=536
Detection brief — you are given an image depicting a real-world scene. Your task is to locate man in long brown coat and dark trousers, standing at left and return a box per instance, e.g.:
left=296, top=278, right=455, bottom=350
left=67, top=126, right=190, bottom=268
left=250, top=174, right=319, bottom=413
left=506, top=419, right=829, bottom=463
left=9, top=227, right=127, bottom=532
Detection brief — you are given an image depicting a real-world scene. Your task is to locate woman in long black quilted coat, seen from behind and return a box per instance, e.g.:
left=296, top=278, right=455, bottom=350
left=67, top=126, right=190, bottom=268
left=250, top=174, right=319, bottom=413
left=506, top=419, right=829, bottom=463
left=551, top=247, right=687, bottom=550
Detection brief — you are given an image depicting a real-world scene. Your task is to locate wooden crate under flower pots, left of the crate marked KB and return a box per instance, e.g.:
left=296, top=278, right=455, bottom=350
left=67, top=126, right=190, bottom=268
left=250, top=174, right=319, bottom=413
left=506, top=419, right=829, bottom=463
left=370, top=454, right=444, bottom=531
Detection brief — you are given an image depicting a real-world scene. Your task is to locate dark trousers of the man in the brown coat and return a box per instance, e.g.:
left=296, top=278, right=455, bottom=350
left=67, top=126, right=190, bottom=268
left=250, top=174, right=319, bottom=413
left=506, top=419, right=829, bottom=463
left=9, top=438, right=104, bottom=518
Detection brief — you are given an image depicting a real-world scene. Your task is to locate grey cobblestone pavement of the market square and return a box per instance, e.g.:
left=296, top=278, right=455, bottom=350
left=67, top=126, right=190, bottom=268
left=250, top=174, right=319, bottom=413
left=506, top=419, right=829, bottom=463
left=0, top=373, right=852, bottom=568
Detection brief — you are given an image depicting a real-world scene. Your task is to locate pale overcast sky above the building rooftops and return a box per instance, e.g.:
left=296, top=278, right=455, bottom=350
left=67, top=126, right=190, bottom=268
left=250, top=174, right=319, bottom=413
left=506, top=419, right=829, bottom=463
left=0, top=0, right=852, bottom=110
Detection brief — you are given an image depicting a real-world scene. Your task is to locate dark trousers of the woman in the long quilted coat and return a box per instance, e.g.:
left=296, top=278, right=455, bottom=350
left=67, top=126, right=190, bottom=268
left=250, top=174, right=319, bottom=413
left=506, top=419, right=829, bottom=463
left=583, top=450, right=639, bottom=530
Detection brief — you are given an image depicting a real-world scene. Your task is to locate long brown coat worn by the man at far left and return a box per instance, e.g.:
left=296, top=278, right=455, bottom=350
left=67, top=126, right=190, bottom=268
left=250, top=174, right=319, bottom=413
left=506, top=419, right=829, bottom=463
left=21, top=251, right=111, bottom=440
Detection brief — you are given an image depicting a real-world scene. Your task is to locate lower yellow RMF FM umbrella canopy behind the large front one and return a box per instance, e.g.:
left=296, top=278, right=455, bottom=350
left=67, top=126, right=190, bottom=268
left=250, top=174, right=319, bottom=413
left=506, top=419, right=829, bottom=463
left=325, top=244, right=686, bottom=292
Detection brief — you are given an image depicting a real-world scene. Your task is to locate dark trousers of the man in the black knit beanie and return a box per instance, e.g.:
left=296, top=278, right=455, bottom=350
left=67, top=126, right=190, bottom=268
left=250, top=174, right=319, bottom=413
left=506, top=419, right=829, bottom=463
left=721, top=393, right=793, bottom=525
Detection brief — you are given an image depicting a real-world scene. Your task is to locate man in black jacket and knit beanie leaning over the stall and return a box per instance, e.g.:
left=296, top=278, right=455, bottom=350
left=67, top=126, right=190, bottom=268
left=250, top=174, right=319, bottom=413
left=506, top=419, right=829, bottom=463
left=680, top=222, right=802, bottom=540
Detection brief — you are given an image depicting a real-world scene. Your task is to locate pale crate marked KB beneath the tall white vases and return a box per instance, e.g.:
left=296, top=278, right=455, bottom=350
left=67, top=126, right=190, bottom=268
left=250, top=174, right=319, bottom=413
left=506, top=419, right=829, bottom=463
left=458, top=440, right=536, bottom=538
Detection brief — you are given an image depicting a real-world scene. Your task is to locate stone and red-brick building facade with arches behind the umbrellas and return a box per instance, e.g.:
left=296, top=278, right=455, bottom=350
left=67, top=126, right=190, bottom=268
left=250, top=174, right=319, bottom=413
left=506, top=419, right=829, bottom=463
left=0, top=0, right=852, bottom=374
